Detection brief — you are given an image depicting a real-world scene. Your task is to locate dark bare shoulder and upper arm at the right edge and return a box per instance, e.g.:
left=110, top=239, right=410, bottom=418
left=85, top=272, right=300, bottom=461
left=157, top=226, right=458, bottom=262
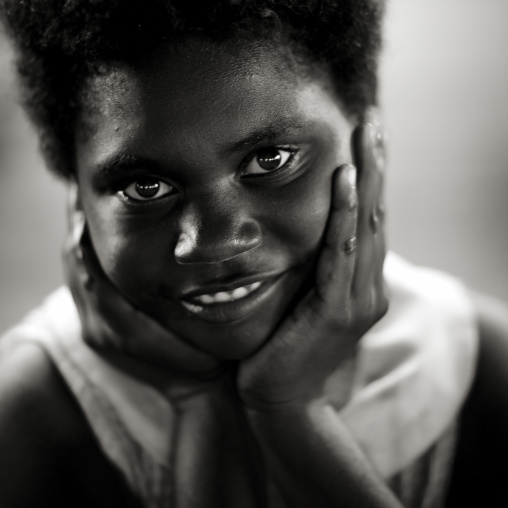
left=447, top=293, right=508, bottom=507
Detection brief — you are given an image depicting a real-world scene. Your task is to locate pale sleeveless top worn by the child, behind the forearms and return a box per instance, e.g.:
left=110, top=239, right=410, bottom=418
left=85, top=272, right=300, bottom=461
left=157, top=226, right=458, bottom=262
left=0, top=253, right=477, bottom=508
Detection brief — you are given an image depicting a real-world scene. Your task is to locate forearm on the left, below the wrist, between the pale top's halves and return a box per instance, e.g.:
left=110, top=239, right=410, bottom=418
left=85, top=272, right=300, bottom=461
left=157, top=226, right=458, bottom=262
left=173, top=384, right=261, bottom=508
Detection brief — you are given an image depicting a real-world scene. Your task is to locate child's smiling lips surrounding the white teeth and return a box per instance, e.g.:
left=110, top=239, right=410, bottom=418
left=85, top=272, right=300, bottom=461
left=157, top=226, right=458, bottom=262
left=180, top=273, right=285, bottom=323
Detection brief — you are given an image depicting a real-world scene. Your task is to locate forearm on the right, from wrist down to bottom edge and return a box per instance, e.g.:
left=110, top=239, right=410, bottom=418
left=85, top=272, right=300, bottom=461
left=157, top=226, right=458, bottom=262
left=248, top=401, right=401, bottom=508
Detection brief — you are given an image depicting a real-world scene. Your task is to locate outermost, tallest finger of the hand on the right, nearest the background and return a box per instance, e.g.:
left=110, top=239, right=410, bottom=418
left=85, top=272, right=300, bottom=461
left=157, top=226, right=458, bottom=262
left=353, top=118, right=381, bottom=298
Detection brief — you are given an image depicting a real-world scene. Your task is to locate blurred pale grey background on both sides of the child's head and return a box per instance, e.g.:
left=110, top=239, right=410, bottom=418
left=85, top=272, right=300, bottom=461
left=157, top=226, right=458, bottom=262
left=0, top=0, right=508, bottom=332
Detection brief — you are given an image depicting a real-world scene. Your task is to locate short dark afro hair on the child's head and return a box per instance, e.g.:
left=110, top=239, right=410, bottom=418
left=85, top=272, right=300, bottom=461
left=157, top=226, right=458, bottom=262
left=0, top=0, right=384, bottom=178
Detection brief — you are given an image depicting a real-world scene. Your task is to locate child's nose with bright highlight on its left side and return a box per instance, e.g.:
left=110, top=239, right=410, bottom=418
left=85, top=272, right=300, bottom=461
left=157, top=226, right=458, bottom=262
left=175, top=196, right=262, bottom=265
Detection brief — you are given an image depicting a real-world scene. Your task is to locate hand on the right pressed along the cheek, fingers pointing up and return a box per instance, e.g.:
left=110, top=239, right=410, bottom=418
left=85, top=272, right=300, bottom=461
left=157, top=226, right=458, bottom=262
left=237, top=118, right=388, bottom=412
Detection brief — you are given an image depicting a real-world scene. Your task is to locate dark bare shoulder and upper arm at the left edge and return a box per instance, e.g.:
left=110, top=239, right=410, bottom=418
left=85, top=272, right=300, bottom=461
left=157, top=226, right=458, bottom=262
left=0, top=336, right=139, bottom=508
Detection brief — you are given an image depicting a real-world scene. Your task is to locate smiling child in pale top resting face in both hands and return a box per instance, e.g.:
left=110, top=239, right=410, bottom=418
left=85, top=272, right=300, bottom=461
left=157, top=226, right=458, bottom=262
left=0, top=0, right=508, bottom=508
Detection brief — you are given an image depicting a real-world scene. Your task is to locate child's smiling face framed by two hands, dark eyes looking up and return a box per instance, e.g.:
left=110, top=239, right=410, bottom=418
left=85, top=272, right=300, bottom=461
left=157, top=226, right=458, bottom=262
left=77, top=37, right=353, bottom=359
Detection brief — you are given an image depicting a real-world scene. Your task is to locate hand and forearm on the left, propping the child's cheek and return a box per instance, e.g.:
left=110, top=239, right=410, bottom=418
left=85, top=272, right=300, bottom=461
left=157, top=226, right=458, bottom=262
left=64, top=193, right=266, bottom=506
